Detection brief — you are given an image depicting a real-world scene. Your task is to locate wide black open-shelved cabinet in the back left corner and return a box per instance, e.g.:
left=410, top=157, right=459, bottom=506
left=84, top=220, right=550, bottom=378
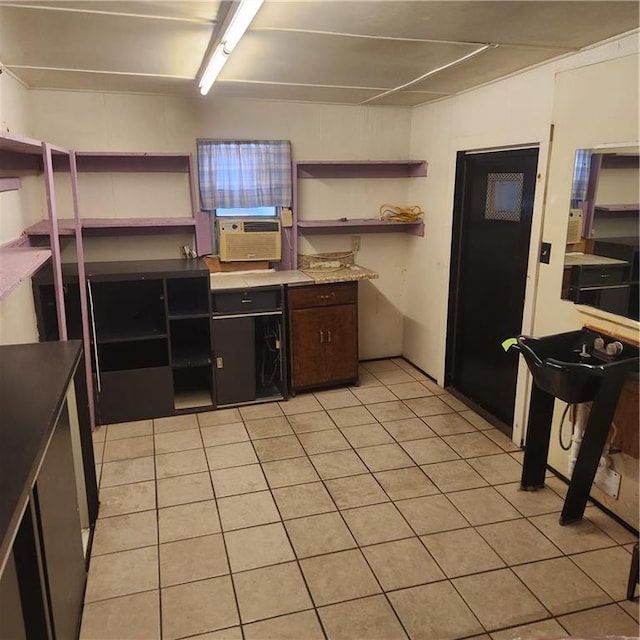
left=33, top=259, right=214, bottom=424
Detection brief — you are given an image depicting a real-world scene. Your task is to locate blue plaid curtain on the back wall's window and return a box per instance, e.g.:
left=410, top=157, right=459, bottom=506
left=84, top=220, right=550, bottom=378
left=198, top=140, right=293, bottom=211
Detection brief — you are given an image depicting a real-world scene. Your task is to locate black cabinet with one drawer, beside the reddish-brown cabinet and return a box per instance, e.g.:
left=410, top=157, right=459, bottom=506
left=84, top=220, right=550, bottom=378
left=211, top=286, right=288, bottom=406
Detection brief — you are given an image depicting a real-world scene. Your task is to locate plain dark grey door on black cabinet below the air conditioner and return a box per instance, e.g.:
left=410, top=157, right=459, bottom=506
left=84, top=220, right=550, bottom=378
left=212, top=316, right=256, bottom=405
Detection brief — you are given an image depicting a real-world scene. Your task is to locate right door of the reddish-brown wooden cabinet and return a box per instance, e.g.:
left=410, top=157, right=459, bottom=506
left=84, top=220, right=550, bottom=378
left=325, top=304, right=358, bottom=382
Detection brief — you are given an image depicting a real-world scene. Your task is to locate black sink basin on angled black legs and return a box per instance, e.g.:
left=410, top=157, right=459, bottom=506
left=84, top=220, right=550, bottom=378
left=514, top=327, right=640, bottom=404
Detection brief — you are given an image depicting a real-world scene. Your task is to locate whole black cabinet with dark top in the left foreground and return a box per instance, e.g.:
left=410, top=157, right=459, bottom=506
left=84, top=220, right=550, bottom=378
left=0, top=341, right=98, bottom=640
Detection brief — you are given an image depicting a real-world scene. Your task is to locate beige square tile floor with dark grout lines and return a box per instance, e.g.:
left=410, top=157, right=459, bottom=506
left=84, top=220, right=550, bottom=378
left=81, top=359, right=638, bottom=640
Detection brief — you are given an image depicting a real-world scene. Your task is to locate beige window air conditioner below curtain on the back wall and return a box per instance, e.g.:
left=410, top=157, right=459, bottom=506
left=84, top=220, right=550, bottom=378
left=217, top=220, right=282, bottom=262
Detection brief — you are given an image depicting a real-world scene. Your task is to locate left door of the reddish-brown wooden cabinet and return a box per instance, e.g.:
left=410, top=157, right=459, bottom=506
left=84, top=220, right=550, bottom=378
left=290, top=308, right=328, bottom=389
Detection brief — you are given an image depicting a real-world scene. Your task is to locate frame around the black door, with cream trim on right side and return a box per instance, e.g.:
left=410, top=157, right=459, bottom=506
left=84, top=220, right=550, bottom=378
left=443, top=144, right=544, bottom=446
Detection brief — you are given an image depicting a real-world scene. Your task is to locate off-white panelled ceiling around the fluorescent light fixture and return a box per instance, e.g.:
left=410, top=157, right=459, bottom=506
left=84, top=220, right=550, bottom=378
left=0, top=0, right=640, bottom=106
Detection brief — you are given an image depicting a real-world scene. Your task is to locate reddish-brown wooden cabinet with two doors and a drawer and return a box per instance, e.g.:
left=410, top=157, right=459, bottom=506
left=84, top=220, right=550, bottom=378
left=288, top=282, right=358, bottom=391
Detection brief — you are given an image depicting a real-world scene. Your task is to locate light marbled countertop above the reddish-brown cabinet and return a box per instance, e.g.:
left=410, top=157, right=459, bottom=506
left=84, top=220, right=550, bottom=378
left=209, top=265, right=378, bottom=291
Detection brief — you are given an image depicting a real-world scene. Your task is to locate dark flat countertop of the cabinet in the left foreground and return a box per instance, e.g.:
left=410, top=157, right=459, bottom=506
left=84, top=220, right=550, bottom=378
left=0, top=340, right=82, bottom=575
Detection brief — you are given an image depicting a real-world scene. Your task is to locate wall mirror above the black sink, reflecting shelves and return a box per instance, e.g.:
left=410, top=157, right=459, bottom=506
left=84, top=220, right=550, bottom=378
left=562, top=143, right=640, bottom=320
